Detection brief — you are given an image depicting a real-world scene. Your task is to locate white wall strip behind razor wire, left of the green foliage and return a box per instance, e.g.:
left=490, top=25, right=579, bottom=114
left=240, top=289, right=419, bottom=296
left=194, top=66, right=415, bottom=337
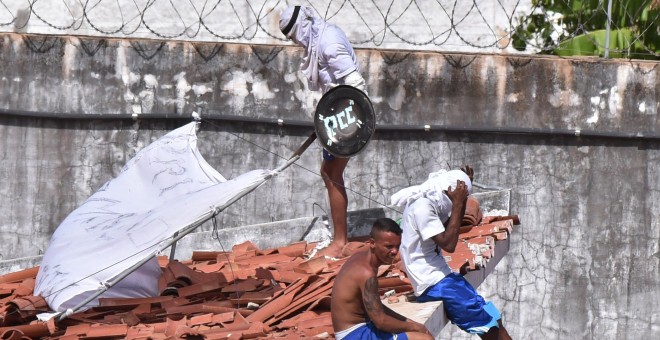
left=0, top=0, right=529, bottom=49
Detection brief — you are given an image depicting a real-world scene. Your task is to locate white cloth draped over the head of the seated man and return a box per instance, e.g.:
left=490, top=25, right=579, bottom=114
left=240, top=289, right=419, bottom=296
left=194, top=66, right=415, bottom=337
left=390, top=170, right=472, bottom=212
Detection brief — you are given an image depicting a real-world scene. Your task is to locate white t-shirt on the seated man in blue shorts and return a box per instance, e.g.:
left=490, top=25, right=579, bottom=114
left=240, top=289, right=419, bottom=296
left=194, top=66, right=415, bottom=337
left=399, top=197, right=451, bottom=296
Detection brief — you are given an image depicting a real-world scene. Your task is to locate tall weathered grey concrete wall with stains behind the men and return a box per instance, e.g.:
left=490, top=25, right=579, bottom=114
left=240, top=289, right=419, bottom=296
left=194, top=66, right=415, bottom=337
left=0, top=35, right=660, bottom=339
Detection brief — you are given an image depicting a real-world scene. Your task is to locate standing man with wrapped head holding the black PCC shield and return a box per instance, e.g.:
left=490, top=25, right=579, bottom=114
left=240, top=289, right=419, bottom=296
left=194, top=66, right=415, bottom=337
left=279, top=6, right=366, bottom=257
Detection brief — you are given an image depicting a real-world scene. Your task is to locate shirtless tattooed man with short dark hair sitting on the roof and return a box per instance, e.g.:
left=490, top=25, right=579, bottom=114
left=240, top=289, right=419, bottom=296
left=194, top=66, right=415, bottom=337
left=330, top=218, right=433, bottom=340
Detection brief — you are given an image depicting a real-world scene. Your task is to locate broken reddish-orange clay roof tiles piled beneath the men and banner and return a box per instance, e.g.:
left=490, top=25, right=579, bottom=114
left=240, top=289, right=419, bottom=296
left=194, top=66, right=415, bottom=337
left=0, top=209, right=518, bottom=340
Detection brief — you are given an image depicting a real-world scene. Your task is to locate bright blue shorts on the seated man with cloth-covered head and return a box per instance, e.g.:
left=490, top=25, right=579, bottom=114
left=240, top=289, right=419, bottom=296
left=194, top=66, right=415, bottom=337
left=417, top=273, right=502, bottom=334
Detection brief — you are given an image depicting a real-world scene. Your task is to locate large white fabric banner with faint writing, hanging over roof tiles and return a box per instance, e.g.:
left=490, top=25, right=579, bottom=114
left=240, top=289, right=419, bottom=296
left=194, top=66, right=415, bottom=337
left=35, top=122, right=272, bottom=311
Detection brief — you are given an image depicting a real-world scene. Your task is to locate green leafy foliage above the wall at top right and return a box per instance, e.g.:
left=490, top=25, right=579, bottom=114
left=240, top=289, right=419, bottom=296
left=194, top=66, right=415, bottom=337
left=512, top=0, right=660, bottom=60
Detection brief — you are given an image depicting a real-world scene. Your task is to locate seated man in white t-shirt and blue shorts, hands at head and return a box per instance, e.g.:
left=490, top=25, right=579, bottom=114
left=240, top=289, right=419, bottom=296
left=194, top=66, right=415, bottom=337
left=392, top=166, right=511, bottom=339
